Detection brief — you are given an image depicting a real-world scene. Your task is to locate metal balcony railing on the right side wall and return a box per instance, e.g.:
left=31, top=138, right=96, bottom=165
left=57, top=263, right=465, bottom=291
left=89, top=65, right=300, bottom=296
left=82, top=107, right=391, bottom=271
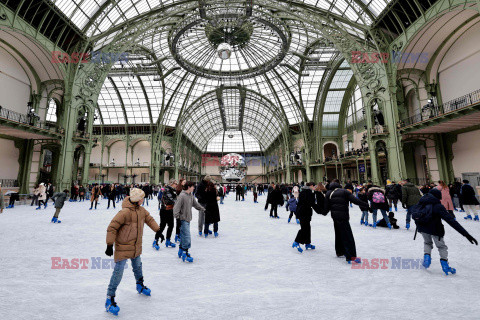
left=398, top=89, right=480, bottom=128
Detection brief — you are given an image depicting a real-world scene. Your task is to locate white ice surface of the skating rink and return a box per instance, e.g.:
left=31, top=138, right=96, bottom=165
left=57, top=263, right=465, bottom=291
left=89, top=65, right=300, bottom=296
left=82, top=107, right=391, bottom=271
left=0, top=194, right=480, bottom=319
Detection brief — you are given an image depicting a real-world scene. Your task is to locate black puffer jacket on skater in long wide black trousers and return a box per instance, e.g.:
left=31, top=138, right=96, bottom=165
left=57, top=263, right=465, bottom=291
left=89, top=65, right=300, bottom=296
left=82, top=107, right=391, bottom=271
left=325, top=183, right=368, bottom=221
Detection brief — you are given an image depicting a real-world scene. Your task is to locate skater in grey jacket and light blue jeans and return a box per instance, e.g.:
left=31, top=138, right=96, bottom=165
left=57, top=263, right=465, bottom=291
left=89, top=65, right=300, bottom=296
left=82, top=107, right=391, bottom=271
left=173, top=181, right=205, bottom=262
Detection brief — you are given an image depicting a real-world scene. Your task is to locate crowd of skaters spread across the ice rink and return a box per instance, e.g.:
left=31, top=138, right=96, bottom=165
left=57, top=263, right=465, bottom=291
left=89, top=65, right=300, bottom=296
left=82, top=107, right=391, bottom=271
left=0, top=175, right=479, bottom=315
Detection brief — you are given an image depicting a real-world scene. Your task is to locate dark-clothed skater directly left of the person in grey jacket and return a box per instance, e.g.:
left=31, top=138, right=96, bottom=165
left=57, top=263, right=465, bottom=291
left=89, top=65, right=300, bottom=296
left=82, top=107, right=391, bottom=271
left=153, top=179, right=177, bottom=250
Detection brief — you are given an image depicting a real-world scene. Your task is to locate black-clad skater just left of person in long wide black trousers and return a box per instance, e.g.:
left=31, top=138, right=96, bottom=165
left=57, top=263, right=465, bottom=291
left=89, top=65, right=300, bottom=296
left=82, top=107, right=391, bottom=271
left=292, top=182, right=325, bottom=253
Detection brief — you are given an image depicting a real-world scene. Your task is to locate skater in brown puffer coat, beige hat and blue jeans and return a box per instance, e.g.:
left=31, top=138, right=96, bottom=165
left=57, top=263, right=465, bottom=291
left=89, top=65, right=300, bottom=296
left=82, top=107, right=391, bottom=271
left=105, top=188, right=164, bottom=315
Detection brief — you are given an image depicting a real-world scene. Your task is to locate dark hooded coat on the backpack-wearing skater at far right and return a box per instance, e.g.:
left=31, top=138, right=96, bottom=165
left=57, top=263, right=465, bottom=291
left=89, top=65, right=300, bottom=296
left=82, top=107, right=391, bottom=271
left=415, top=189, right=468, bottom=237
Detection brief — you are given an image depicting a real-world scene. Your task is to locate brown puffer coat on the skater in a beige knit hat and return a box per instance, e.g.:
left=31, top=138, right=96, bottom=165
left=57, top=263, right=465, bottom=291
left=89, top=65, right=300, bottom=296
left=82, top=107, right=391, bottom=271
left=107, top=197, right=160, bottom=262
